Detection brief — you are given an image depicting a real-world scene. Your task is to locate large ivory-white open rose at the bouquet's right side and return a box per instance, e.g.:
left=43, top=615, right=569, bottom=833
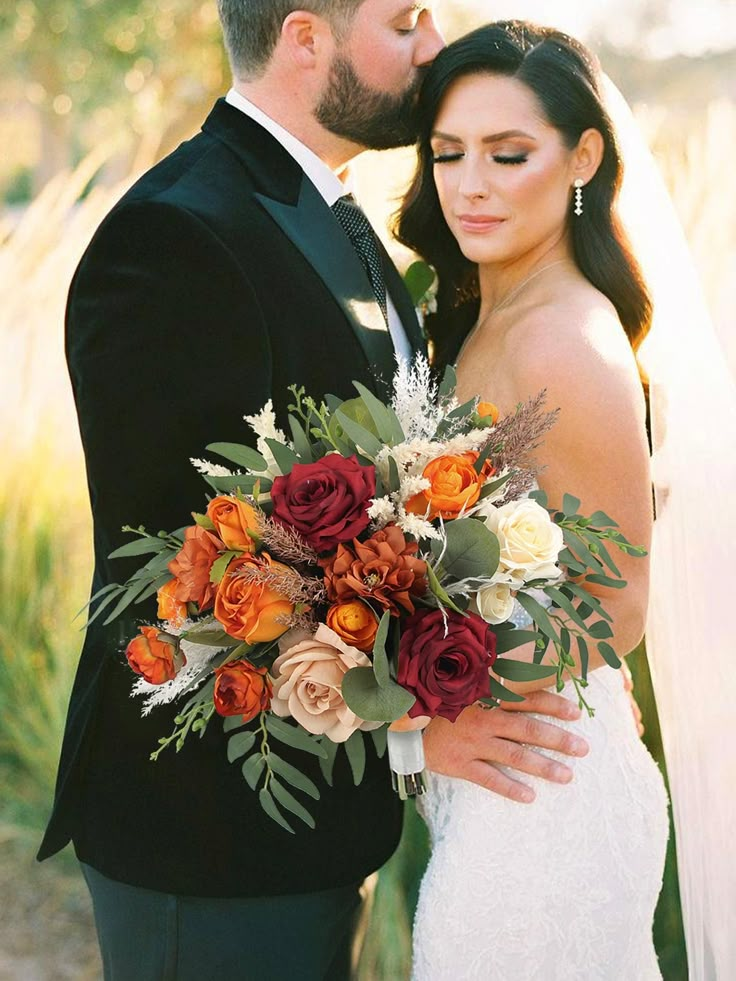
left=485, top=498, right=564, bottom=585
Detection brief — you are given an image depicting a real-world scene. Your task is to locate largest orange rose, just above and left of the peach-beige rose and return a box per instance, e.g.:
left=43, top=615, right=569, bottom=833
left=215, top=552, right=294, bottom=644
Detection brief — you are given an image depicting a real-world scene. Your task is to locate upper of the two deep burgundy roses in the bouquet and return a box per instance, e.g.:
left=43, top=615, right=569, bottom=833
left=271, top=453, right=376, bottom=552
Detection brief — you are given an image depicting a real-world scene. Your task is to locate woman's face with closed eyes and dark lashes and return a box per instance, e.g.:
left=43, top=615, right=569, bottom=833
left=431, top=75, right=577, bottom=264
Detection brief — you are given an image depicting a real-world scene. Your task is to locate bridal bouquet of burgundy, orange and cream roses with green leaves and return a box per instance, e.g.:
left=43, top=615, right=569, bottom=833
left=92, top=359, right=642, bottom=831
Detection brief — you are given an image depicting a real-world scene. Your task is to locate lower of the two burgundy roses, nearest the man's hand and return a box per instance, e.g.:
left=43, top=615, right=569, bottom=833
left=397, top=610, right=496, bottom=722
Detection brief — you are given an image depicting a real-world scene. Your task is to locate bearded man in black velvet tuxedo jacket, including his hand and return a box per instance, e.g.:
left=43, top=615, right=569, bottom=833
left=39, top=0, right=588, bottom=981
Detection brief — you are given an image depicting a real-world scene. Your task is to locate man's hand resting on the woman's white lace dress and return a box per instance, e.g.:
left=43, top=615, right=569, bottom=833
left=424, top=691, right=589, bottom=803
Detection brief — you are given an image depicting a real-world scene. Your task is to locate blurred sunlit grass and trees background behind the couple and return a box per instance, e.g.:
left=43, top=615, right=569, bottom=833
left=0, top=0, right=736, bottom=981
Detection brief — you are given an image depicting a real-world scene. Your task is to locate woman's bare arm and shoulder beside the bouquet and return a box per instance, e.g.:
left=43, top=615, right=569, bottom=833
left=486, top=307, right=653, bottom=694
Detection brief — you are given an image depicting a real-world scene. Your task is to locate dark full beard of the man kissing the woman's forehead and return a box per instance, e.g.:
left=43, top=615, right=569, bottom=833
left=315, top=55, right=423, bottom=150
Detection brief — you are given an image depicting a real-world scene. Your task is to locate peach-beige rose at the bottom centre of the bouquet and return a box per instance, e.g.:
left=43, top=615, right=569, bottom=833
left=271, top=624, right=381, bottom=743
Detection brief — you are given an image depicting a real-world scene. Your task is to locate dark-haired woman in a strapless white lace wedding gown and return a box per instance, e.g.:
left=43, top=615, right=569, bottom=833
left=398, top=22, right=668, bottom=981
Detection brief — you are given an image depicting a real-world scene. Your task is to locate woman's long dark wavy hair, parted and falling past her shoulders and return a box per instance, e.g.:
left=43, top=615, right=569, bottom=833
left=395, top=20, right=652, bottom=366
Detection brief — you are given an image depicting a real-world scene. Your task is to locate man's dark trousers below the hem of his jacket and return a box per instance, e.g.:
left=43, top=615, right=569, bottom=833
left=82, top=864, right=361, bottom=981
